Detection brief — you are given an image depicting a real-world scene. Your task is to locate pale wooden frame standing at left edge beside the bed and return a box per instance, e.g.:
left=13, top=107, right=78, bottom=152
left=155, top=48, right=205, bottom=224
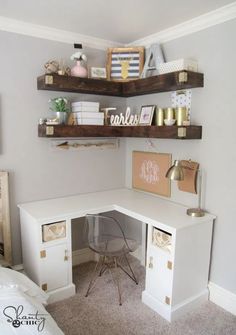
left=0, top=171, right=12, bottom=265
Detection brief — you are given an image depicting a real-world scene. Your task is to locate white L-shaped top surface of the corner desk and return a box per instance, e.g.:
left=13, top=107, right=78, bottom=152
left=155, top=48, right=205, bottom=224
left=18, top=188, right=215, bottom=230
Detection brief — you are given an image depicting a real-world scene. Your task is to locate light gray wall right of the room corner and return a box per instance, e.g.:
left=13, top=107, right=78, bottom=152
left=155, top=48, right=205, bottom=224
left=126, top=20, right=236, bottom=293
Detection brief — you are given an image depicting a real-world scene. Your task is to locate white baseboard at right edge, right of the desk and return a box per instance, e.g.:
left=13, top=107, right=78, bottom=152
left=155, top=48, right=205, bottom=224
left=208, top=282, right=236, bottom=315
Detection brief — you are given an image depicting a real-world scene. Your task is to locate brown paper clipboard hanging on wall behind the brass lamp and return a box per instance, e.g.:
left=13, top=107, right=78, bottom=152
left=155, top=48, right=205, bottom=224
left=178, top=160, right=199, bottom=194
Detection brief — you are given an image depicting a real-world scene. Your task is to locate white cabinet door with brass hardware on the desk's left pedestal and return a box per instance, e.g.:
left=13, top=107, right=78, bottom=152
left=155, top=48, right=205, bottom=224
left=40, top=244, right=69, bottom=291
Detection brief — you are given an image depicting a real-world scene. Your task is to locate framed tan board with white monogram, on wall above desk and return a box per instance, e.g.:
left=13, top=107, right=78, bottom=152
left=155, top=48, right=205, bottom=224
left=132, top=151, right=171, bottom=197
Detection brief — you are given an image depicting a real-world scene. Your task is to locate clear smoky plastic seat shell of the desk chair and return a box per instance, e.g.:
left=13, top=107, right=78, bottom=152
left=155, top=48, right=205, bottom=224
left=85, top=214, right=131, bottom=256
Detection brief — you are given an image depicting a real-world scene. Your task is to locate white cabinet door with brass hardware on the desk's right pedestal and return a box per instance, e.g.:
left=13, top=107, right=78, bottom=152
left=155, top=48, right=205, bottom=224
left=146, top=246, right=173, bottom=305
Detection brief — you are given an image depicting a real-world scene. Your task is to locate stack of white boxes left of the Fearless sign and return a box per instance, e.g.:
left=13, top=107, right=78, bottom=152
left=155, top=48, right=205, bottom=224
left=71, top=101, right=104, bottom=125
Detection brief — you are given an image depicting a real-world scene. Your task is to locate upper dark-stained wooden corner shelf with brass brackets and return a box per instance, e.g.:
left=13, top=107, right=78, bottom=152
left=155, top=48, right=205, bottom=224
left=37, top=71, right=204, bottom=97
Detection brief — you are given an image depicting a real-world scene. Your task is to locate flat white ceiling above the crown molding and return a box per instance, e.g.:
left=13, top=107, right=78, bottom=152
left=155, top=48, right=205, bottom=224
left=0, top=0, right=232, bottom=43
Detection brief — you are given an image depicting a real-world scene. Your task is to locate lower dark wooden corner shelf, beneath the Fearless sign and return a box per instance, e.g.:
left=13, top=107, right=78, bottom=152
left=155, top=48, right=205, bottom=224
left=38, top=125, right=202, bottom=140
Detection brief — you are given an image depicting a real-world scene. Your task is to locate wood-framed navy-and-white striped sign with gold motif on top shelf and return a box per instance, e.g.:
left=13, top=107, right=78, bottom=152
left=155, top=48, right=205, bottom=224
left=107, top=47, right=144, bottom=81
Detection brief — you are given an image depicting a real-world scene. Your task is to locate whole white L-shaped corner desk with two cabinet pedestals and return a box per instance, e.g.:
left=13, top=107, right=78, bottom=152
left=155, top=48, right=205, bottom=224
left=19, top=189, right=215, bottom=321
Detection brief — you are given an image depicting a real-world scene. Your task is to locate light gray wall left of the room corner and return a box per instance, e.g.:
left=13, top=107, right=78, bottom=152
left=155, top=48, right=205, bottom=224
left=0, top=32, right=125, bottom=264
